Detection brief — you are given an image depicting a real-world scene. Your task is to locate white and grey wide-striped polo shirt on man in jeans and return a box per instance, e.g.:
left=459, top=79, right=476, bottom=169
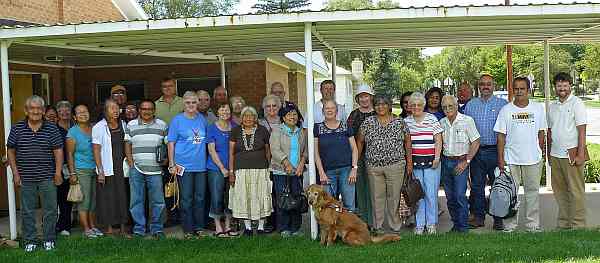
left=125, top=118, right=167, bottom=175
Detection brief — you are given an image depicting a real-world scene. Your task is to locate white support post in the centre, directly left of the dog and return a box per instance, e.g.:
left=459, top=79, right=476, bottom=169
left=304, top=22, right=317, bottom=239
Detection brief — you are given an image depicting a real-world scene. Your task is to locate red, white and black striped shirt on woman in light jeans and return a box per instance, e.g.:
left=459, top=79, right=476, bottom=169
left=404, top=113, right=444, bottom=156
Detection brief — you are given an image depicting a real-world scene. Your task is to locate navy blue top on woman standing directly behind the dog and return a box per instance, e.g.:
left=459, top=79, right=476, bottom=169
left=313, top=121, right=354, bottom=171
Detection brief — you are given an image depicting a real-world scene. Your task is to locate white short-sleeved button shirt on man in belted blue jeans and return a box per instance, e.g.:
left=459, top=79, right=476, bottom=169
left=440, top=112, right=480, bottom=156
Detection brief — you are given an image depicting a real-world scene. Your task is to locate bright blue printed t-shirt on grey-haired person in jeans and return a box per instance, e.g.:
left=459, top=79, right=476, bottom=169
left=167, top=113, right=207, bottom=172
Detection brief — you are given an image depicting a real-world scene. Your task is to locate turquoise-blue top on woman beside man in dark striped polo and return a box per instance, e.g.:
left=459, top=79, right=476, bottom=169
left=67, top=125, right=96, bottom=169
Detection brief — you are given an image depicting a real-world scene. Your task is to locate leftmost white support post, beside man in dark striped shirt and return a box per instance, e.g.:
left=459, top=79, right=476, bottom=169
left=0, top=41, right=17, bottom=240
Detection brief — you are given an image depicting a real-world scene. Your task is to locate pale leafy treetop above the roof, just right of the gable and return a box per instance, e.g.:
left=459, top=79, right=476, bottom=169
left=138, top=0, right=239, bottom=19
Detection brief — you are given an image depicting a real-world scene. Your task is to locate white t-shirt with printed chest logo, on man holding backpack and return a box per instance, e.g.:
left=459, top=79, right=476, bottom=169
left=494, top=101, right=547, bottom=165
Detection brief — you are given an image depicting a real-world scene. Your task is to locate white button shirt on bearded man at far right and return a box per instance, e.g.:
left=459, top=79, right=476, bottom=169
left=548, top=95, right=587, bottom=158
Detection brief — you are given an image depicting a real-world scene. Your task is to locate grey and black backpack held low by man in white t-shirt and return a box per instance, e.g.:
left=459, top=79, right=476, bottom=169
left=487, top=167, right=519, bottom=219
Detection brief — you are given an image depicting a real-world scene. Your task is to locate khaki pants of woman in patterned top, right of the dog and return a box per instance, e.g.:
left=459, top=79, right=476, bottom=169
left=368, top=162, right=406, bottom=231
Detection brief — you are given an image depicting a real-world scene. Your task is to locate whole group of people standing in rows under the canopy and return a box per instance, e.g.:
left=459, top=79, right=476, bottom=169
left=7, top=73, right=586, bottom=251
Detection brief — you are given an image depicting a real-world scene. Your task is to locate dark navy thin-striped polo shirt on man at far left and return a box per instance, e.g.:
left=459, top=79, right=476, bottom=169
left=6, top=119, right=64, bottom=182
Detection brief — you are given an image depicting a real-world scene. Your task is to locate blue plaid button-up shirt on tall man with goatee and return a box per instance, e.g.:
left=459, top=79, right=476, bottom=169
left=465, top=96, right=508, bottom=146
